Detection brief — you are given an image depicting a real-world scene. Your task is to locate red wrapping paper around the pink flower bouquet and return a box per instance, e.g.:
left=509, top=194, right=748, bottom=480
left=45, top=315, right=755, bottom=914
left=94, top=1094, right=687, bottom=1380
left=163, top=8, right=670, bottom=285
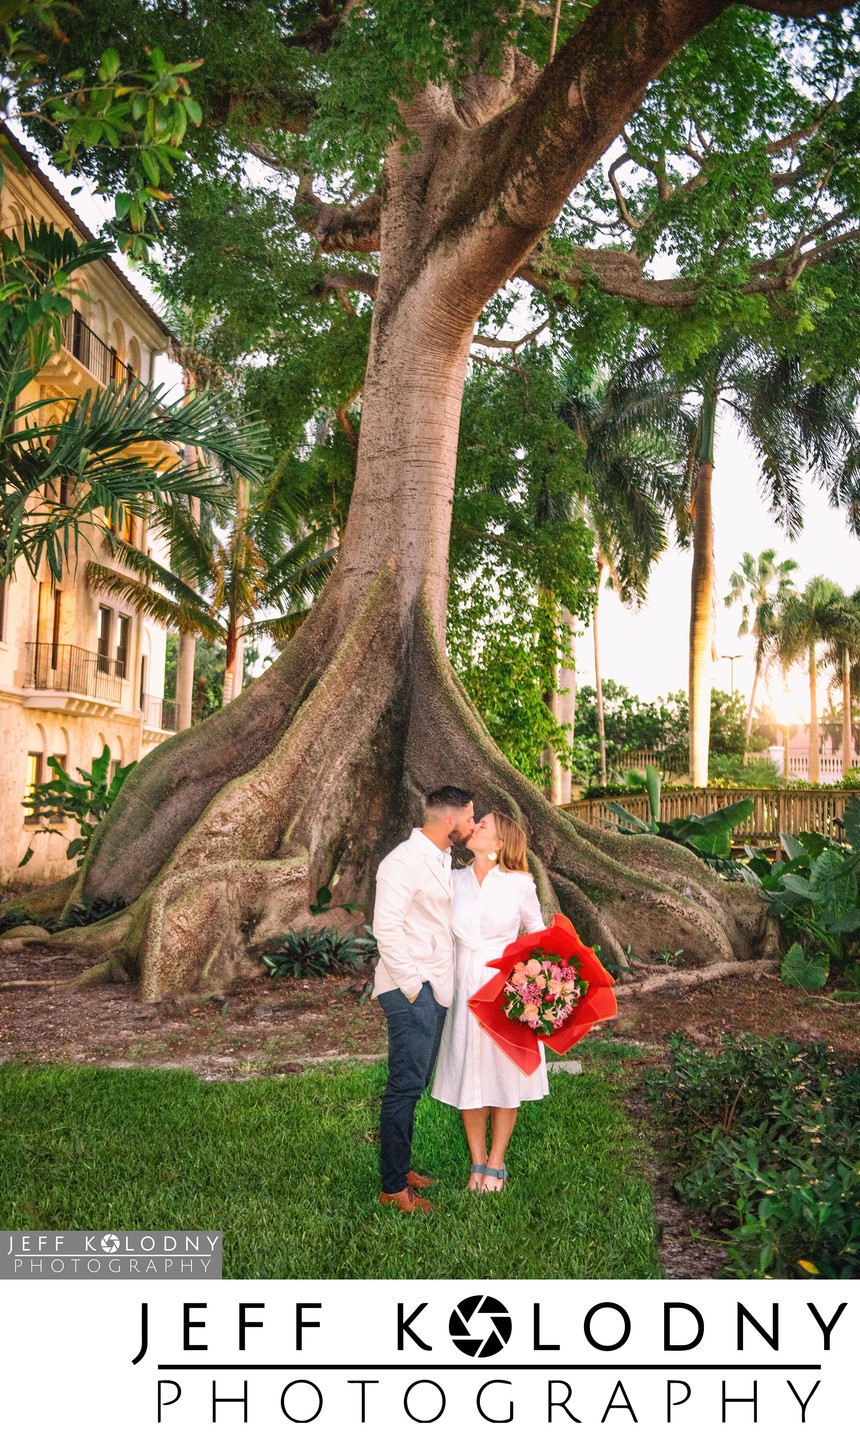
left=469, top=913, right=617, bottom=1076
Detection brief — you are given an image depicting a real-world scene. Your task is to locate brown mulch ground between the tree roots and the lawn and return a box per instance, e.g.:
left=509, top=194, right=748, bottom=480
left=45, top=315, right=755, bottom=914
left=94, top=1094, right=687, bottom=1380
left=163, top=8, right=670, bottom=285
left=0, top=943, right=860, bottom=1279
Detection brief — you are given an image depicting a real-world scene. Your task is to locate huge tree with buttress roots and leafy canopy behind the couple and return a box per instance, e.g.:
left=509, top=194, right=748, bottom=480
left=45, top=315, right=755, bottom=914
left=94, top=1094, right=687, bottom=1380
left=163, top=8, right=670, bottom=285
left=13, top=0, right=856, bottom=996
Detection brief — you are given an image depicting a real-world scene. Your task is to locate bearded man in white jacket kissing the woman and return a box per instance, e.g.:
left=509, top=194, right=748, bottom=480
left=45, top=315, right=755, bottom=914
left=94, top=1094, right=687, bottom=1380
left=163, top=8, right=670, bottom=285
left=373, top=788, right=475, bottom=1214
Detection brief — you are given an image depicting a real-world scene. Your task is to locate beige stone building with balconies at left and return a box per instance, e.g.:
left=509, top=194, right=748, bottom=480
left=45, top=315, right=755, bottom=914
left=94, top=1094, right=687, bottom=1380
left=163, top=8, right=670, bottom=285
left=0, top=132, right=183, bottom=884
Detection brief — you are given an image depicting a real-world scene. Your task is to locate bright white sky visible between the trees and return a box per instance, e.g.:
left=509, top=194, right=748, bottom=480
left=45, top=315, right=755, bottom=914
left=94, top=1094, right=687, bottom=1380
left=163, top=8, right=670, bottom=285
left=30, top=136, right=860, bottom=723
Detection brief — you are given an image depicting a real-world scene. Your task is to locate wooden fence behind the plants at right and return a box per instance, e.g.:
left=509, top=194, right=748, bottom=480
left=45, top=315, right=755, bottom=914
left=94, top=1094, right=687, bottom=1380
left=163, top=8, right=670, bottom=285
left=561, top=788, right=860, bottom=842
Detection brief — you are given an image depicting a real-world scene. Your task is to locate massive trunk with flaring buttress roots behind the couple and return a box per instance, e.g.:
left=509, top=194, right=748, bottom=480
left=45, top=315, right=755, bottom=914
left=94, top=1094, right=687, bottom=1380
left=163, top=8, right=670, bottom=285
left=16, top=0, right=772, bottom=999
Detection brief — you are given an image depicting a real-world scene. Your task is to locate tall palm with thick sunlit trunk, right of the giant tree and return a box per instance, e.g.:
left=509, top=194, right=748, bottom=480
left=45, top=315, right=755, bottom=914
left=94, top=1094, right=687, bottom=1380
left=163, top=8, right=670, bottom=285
left=625, top=344, right=860, bottom=786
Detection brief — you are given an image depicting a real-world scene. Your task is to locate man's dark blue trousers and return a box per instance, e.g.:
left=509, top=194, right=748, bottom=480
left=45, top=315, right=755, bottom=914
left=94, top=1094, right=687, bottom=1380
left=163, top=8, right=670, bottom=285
left=378, top=982, right=448, bottom=1195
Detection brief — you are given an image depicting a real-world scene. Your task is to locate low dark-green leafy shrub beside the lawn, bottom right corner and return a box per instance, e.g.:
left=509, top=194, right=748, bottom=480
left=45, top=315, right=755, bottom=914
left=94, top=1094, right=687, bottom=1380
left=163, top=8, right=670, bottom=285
left=646, top=1036, right=860, bottom=1280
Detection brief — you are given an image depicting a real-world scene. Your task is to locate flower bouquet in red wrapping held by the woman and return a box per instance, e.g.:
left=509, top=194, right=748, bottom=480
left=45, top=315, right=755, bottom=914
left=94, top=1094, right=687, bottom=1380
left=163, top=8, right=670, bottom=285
left=469, top=913, right=617, bottom=1076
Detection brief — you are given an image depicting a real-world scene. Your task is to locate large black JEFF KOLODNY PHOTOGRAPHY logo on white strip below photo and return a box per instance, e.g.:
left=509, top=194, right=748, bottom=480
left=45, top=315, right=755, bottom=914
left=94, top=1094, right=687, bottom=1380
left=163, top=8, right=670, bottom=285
left=129, top=1281, right=850, bottom=1429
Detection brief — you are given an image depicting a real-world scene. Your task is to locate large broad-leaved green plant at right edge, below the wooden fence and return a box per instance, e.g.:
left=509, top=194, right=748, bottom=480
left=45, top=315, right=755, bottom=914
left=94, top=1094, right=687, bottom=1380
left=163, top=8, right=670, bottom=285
left=744, top=798, right=860, bottom=990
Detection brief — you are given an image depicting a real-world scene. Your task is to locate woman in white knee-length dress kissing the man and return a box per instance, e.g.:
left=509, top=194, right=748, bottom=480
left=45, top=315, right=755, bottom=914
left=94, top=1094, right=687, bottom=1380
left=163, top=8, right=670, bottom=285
left=432, top=812, right=550, bottom=1191
